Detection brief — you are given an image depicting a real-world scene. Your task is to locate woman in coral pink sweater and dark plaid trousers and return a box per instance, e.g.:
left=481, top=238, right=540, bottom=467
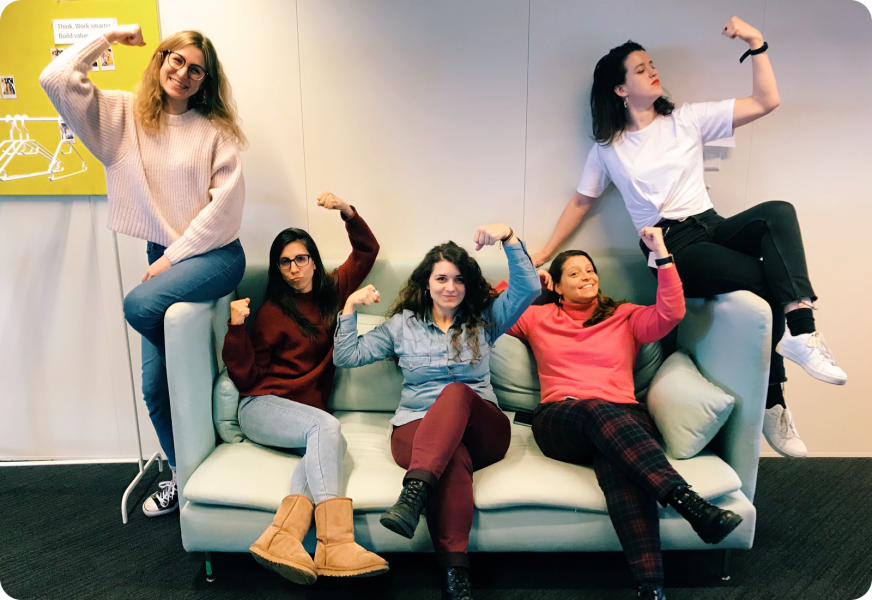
left=507, top=227, right=742, bottom=600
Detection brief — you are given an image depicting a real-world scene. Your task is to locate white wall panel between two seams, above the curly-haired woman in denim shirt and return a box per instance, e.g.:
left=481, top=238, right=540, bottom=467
left=299, top=0, right=528, bottom=257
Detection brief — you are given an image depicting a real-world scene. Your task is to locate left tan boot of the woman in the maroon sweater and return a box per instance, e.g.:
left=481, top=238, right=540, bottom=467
left=249, top=494, right=318, bottom=585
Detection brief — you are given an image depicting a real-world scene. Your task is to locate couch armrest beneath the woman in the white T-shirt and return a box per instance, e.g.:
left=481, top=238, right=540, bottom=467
left=678, top=291, right=772, bottom=502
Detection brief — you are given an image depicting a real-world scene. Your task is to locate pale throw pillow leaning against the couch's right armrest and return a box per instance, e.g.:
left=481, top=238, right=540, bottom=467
left=648, top=351, right=736, bottom=458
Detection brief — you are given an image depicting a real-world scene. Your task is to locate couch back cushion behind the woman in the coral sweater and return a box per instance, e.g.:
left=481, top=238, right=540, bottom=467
left=490, top=335, right=663, bottom=412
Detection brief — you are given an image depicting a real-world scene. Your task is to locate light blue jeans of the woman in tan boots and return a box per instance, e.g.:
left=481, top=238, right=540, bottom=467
left=239, top=396, right=346, bottom=504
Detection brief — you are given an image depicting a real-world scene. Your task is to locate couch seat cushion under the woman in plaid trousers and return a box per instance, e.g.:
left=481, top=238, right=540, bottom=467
left=473, top=424, right=742, bottom=513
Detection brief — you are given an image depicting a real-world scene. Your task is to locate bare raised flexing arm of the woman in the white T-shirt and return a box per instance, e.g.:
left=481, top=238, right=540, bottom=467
left=721, top=17, right=781, bottom=129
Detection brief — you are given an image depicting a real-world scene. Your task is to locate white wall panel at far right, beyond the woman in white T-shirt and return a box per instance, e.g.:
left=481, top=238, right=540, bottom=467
left=748, top=0, right=872, bottom=455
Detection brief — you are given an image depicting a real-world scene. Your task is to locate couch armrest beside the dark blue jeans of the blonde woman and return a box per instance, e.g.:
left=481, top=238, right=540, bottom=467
left=164, top=296, right=230, bottom=498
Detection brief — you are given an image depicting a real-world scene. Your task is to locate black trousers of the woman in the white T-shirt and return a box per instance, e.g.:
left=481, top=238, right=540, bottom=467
left=639, top=201, right=817, bottom=385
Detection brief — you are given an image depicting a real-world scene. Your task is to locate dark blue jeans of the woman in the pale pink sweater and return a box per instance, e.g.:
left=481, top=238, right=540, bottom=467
left=124, top=240, right=245, bottom=470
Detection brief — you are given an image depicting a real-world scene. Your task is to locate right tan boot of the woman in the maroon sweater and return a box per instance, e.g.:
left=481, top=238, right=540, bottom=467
left=315, top=498, right=388, bottom=577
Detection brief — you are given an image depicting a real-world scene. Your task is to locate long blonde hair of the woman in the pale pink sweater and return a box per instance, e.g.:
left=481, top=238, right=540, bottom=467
left=133, top=31, right=246, bottom=147
